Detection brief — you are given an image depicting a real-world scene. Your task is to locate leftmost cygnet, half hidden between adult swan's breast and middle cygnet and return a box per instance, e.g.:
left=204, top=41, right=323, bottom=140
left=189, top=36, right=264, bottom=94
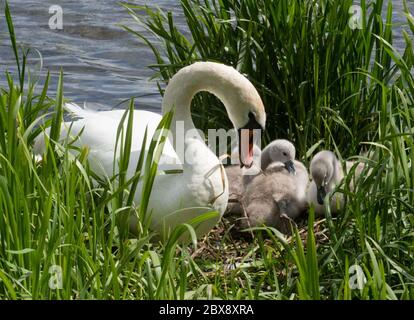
left=225, top=145, right=262, bottom=215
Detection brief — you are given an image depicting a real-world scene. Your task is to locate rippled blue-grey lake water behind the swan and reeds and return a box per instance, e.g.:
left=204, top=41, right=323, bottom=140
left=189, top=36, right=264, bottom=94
left=0, top=0, right=414, bottom=110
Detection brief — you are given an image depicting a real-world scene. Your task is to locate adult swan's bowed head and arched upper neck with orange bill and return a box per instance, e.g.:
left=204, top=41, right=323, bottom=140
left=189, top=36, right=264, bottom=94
left=163, top=62, right=266, bottom=168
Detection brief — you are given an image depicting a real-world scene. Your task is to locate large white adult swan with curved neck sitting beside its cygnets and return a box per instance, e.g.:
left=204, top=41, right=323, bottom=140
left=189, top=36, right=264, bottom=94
left=36, top=62, right=266, bottom=238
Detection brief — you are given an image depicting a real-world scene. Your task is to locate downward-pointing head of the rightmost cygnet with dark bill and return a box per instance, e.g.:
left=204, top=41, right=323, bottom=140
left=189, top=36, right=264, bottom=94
left=310, top=151, right=338, bottom=205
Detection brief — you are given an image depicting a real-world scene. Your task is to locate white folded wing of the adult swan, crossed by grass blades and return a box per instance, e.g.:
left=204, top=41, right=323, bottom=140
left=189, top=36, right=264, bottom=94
left=35, top=103, right=181, bottom=175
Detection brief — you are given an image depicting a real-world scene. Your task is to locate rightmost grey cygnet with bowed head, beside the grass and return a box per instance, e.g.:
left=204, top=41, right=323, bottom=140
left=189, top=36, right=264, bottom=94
left=307, top=150, right=364, bottom=216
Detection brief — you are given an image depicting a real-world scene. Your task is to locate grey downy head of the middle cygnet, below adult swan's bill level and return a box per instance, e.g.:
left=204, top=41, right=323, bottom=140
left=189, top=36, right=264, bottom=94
left=262, top=139, right=296, bottom=174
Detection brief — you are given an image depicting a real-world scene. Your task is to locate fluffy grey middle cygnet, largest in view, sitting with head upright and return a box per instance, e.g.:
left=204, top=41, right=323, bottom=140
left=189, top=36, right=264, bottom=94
left=243, top=140, right=309, bottom=233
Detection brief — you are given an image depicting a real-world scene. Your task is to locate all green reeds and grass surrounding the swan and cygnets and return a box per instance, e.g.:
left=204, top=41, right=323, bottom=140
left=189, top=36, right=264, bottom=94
left=0, top=0, right=414, bottom=299
